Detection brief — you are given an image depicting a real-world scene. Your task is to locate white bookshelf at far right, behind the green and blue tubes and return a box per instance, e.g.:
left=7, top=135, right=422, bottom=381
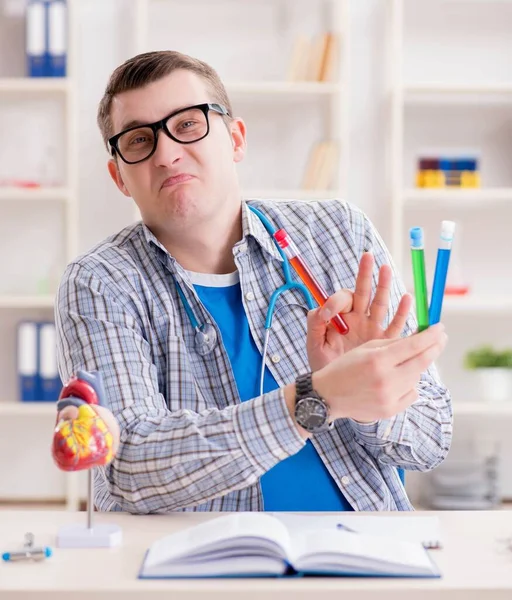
left=386, top=0, right=512, bottom=496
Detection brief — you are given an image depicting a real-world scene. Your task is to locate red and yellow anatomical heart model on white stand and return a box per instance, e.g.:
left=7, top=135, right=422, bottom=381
left=52, top=371, right=122, bottom=548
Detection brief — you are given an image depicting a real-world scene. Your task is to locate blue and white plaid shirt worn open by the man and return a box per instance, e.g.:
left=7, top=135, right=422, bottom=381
left=56, top=200, right=452, bottom=513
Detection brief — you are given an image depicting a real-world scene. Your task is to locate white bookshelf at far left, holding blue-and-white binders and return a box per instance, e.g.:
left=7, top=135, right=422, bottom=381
left=0, top=0, right=80, bottom=510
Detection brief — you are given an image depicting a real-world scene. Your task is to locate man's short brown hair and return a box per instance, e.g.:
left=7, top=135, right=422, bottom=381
left=97, top=50, right=233, bottom=149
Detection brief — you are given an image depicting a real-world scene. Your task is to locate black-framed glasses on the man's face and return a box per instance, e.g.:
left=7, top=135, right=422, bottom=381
left=108, top=103, right=230, bottom=165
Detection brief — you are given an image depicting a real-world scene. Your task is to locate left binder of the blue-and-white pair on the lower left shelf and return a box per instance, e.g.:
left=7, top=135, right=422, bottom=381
left=17, top=321, right=39, bottom=402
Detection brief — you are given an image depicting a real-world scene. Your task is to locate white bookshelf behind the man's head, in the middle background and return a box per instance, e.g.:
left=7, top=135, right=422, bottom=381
left=132, top=0, right=350, bottom=219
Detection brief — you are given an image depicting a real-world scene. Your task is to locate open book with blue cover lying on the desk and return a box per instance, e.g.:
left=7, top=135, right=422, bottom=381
left=139, top=512, right=440, bottom=578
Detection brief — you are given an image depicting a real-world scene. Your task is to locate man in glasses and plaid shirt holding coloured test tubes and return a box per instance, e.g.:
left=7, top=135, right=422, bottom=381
left=56, top=52, right=452, bottom=513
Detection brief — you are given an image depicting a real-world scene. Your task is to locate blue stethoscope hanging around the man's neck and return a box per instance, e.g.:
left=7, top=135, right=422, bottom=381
left=174, top=206, right=315, bottom=395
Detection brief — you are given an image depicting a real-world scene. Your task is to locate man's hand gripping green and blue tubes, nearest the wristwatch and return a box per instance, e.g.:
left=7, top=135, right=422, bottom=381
left=313, top=323, right=447, bottom=422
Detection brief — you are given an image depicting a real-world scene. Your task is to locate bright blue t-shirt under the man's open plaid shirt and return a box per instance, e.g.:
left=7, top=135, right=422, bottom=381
left=191, top=273, right=353, bottom=511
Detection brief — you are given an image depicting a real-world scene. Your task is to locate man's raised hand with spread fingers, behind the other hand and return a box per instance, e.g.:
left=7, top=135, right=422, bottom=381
left=306, top=253, right=412, bottom=371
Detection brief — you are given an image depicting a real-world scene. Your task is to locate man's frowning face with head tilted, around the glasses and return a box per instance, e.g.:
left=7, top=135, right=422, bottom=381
left=109, top=70, right=245, bottom=229
